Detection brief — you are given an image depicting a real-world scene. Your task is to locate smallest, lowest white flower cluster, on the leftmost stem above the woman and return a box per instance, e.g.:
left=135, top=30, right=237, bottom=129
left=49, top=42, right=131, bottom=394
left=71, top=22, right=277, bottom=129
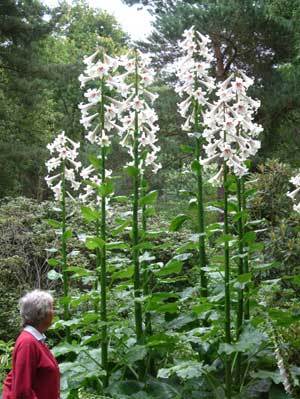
left=45, top=132, right=81, bottom=201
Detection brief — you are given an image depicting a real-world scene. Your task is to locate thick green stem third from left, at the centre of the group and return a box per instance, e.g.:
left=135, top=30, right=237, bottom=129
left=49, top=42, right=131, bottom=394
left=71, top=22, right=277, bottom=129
left=132, top=52, right=143, bottom=344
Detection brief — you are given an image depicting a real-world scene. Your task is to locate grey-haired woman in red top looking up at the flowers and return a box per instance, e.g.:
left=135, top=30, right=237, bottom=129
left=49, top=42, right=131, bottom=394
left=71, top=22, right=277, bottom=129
left=3, top=290, right=60, bottom=399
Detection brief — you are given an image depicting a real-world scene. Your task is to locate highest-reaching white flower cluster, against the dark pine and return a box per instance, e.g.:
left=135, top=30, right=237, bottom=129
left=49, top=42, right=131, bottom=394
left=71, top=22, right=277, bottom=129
left=175, top=27, right=215, bottom=131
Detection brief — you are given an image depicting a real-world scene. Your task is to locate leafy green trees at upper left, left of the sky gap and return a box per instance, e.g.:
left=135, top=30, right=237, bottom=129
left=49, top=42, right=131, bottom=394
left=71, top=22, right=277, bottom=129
left=0, top=0, right=127, bottom=199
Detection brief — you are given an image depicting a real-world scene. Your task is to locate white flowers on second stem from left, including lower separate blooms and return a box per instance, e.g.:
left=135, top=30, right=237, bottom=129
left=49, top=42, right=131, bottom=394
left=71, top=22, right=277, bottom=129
left=79, top=50, right=128, bottom=207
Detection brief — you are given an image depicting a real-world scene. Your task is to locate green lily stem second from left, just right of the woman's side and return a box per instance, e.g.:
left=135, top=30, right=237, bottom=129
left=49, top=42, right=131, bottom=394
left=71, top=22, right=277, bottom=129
left=100, top=78, right=109, bottom=386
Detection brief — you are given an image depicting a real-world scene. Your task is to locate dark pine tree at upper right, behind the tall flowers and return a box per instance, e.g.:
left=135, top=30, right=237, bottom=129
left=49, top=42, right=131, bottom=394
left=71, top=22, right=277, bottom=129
left=123, top=0, right=300, bottom=160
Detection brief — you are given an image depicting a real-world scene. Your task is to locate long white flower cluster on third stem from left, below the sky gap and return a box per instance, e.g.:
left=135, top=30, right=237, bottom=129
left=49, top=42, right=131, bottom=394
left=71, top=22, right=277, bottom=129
left=115, top=51, right=161, bottom=173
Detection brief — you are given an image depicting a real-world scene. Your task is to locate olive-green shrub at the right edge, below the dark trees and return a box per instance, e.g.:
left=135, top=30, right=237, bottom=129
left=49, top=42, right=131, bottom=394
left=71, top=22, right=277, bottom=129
left=250, top=160, right=300, bottom=282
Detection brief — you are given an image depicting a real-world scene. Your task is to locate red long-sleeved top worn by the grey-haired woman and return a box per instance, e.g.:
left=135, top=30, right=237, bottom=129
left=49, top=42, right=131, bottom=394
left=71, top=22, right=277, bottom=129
left=2, top=331, right=60, bottom=399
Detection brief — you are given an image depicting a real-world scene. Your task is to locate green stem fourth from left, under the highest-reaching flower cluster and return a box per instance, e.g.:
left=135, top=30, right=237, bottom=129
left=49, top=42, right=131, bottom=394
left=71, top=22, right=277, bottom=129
left=194, top=101, right=208, bottom=297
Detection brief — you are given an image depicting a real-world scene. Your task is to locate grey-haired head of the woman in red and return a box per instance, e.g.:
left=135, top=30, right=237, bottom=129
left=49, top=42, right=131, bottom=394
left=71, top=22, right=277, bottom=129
left=19, top=290, right=54, bottom=327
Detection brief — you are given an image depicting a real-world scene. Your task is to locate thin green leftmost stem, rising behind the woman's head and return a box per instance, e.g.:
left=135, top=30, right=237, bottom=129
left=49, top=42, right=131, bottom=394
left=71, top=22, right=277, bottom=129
left=61, top=162, right=70, bottom=320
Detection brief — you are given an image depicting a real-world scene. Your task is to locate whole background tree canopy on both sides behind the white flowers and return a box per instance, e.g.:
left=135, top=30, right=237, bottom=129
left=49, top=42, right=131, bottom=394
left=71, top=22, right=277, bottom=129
left=0, top=0, right=300, bottom=199
